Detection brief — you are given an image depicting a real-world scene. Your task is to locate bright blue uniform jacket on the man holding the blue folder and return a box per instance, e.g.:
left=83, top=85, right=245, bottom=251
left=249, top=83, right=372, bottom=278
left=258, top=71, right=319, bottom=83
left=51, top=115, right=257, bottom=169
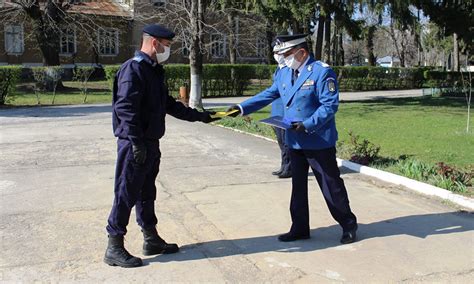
left=240, top=57, right=339, bottom=150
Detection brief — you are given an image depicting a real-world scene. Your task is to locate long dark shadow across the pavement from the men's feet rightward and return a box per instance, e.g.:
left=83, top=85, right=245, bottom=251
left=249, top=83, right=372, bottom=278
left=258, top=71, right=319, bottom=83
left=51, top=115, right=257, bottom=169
left=145, top=212, right=474, bottom=263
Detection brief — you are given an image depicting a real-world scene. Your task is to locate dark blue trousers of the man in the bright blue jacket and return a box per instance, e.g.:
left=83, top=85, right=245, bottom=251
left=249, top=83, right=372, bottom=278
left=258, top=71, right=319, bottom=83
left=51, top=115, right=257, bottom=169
left=290, top=147, right=357, bottom=235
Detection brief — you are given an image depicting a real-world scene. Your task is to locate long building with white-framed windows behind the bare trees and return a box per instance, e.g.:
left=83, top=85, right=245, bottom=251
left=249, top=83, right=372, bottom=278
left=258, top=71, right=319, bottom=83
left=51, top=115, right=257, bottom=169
left=0, top=0, right=268, bottom=67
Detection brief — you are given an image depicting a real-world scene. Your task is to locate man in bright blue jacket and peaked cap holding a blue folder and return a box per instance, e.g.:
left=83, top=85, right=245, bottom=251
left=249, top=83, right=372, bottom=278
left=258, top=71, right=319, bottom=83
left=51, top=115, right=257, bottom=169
left=231, top=35, right=357, bottom=244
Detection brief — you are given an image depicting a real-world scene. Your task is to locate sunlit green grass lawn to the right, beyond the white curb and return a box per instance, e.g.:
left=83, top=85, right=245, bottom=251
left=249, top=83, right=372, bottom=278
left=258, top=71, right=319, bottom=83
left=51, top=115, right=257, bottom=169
left=217, top=97, right=474, bottom=167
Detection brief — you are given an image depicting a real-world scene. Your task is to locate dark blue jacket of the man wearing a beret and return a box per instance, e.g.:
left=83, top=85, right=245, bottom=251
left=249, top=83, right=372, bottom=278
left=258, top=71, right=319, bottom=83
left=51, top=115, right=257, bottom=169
left=112, top=51, right=202, bottom=143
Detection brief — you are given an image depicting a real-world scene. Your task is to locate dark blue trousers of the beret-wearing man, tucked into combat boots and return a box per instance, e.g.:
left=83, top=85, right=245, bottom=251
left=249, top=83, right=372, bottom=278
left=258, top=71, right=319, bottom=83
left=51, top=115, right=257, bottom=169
left=107, top=139, right=161, bottom=236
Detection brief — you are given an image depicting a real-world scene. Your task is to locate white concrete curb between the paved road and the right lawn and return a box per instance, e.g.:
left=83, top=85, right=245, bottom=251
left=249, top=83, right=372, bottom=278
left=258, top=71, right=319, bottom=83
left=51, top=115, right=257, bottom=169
left=214, top=124, right=474, bottom=210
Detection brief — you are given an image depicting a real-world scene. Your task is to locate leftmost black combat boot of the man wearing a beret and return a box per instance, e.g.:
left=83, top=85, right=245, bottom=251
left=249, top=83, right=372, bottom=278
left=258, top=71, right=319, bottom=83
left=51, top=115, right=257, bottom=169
left=104, top=236, right=143, bottom=267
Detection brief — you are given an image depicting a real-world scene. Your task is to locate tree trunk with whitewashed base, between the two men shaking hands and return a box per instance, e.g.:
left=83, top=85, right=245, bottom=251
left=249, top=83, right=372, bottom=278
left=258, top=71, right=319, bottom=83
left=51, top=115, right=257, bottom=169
left=189, top=0, right=204, bottom=109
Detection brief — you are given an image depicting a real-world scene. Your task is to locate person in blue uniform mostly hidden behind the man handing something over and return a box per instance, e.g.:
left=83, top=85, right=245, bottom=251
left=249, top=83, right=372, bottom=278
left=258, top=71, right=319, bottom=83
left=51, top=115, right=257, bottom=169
left=271, top=42, right=291, bottom=178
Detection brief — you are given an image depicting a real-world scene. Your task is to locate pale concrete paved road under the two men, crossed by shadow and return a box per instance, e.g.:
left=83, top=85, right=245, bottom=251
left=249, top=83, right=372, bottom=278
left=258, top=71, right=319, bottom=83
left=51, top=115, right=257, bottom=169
left=0, top=106, right=474, bottom=283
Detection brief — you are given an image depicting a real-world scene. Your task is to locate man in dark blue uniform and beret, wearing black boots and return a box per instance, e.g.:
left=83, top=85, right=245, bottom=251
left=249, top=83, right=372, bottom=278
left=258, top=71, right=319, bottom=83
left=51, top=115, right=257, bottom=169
left=104, top=24, right=218, bottom=267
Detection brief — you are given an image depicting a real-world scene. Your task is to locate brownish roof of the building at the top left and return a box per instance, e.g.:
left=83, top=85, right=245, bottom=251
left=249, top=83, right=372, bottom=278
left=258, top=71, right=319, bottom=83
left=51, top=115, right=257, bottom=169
left=4, top=0, right=132, bottom=17
